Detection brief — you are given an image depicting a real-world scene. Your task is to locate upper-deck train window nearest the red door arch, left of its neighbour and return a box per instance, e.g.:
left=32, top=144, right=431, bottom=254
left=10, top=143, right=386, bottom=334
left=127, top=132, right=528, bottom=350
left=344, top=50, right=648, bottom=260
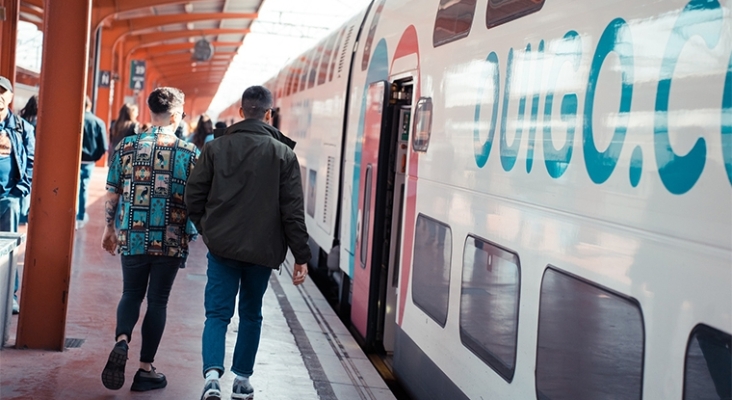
left=432, top=0, right=475, bottom=47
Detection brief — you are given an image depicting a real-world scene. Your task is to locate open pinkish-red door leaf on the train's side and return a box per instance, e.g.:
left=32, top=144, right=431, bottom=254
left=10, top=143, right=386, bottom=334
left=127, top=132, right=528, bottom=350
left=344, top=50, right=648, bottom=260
left=351, top=81, right=390, bottom=348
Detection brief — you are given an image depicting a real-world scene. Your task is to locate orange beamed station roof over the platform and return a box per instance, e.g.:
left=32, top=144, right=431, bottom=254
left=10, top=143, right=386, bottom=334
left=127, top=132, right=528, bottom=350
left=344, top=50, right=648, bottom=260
left=20, top=0, right=264, bottom=117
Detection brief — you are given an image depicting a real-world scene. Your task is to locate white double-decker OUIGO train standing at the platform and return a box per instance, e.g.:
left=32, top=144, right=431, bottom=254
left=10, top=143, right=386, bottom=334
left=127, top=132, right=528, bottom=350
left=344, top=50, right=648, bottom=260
left=223, top=0, right=732, bottom=400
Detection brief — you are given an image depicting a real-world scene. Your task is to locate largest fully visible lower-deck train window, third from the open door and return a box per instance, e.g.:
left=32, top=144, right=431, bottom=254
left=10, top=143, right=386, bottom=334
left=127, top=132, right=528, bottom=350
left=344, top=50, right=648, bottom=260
left=536, top=266, right=645, bottom=400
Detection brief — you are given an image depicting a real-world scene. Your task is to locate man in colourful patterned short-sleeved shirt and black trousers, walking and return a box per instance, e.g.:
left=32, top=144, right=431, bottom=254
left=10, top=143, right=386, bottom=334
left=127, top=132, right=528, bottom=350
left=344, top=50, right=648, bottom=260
left=102, top=87, right=199, bottom=391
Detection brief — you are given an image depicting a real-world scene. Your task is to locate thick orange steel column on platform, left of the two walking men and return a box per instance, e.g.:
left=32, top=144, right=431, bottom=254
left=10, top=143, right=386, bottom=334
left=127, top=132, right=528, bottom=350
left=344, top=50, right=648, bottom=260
left=16, top=0, right=92, bottom=351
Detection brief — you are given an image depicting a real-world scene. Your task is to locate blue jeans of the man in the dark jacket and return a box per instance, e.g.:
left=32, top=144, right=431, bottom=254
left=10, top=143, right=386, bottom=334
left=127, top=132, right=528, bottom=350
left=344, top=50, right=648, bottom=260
left=203, top=253, right=272, bottom=377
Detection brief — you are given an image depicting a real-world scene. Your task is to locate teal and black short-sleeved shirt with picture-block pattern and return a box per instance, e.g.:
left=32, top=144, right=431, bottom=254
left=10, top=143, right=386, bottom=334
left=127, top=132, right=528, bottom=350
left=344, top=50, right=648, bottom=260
left=107, top=126, right=200, bottom=257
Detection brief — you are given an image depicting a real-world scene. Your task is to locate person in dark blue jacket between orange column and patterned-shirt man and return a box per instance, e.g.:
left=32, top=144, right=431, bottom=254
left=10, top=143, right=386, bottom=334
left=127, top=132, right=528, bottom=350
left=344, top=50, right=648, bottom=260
left=76, top=96, right=107, bottom=229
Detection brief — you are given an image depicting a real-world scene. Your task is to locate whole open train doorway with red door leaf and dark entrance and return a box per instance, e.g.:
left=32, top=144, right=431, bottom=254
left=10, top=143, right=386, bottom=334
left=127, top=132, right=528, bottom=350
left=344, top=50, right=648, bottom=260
left=351, top=79, right=412, bottom=353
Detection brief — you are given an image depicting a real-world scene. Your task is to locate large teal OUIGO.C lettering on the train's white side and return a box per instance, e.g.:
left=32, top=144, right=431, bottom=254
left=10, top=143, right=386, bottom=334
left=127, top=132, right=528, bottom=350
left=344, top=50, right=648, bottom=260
left=473, top=0, right=732, bottom=195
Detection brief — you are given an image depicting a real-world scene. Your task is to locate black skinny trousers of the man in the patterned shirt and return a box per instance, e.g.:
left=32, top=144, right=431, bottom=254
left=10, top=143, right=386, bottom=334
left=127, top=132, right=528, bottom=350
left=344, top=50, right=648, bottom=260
left=115, top=255, right=183, bottom=363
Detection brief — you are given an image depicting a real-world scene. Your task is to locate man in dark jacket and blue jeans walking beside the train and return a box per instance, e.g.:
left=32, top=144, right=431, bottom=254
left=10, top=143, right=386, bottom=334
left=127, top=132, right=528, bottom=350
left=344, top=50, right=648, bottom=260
left=185, top=86, right=310, bottom=400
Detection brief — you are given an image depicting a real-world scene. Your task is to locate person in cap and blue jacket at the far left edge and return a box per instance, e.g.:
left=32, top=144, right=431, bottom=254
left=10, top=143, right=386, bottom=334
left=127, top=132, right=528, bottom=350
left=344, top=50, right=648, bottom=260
left=0, top=76, right=36, bottom=314
